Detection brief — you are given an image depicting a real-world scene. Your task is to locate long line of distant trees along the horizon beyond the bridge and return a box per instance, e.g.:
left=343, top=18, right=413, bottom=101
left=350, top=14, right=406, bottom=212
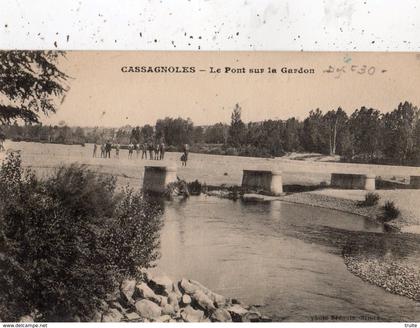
left=2, top=102, right=420, bottom=165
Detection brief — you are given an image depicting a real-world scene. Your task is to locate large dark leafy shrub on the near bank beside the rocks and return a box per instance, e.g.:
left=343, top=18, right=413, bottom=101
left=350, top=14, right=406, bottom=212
left=0, top=154, right=160, bottom=321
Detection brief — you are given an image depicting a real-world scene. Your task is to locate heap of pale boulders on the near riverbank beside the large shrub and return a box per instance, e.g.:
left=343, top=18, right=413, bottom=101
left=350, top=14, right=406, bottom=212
left=100, top=275, right=271, bottom=322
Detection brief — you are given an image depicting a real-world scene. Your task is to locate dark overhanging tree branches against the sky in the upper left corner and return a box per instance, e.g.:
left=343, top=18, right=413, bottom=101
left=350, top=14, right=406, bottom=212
left=0, top=51, right=68, bottom=124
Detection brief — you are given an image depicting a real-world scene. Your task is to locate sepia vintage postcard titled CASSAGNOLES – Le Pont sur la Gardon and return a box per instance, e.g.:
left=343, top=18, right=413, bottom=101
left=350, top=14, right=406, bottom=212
left=0, top=51, right=420, bottom=322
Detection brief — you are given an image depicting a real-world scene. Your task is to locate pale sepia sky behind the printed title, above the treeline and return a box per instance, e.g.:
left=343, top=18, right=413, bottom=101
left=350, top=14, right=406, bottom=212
left=41, top=51, right=420, bottom=127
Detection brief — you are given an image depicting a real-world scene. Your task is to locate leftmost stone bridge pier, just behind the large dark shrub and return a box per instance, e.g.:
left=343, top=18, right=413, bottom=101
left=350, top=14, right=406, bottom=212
left=143, top=166, right=177, bottom=194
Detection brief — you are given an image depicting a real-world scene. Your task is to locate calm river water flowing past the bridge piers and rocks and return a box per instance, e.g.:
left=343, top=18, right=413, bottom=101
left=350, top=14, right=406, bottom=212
left=153, top=196, right=420, bottom=321
